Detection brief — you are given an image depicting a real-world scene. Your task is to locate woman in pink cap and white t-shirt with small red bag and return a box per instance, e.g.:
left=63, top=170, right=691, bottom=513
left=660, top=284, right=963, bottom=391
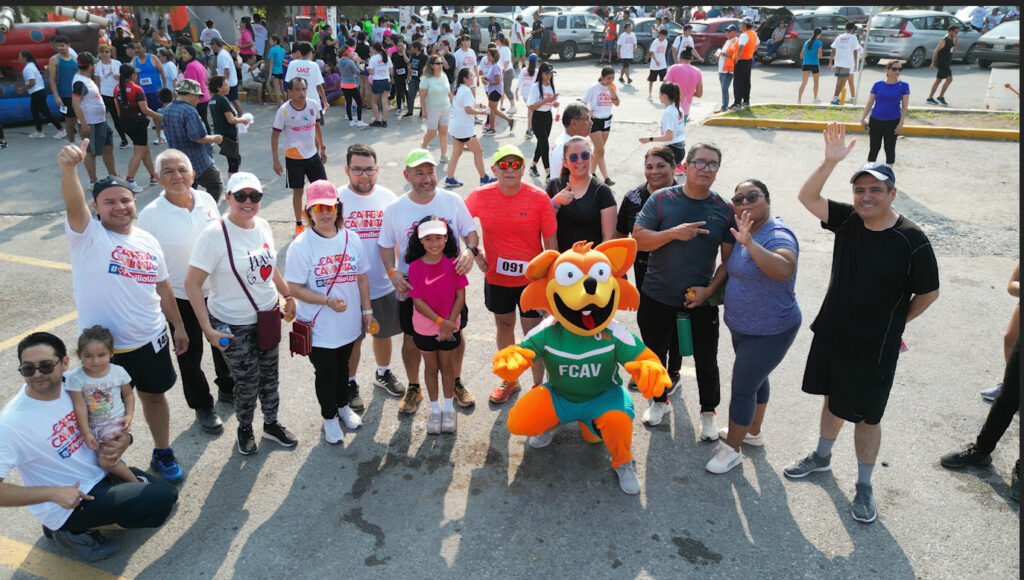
left=285, top=179, right=375, bottom=445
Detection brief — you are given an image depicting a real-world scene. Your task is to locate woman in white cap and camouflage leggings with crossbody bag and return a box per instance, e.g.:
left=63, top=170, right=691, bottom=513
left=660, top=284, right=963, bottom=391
left=185, top=171, right=298, bottom=455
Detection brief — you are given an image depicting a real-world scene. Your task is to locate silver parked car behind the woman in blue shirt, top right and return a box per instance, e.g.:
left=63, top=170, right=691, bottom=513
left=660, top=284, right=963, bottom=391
left=864, top=10, right=981, bottom=69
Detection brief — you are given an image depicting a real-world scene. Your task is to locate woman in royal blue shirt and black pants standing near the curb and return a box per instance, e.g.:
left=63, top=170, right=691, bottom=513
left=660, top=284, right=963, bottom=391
left=860, top=60, right=910, bottom=166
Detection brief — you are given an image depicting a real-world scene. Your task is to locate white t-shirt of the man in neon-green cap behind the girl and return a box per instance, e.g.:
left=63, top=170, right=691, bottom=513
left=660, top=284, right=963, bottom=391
left=377, top=189, right=476, bottom=274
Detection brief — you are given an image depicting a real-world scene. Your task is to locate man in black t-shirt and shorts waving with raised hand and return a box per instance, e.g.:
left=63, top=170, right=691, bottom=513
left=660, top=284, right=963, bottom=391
left=783, top=123, right=939, bottom=524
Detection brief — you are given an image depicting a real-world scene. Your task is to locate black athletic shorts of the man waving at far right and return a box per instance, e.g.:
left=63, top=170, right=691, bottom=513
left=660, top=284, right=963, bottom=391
left=802, top=334, right=899, bottom=425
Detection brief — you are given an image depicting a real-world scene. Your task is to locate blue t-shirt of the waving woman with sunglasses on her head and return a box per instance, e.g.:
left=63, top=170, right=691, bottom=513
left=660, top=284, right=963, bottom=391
left=723, top=217, right=801, bottom=336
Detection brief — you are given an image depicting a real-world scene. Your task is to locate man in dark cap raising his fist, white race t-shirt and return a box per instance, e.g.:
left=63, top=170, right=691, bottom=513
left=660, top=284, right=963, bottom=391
left=57, top=138, right=188, bottom=483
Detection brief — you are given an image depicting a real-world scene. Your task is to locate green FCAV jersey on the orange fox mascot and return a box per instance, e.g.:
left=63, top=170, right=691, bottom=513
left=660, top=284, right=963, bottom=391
left=519, top=317, right=646, bottom=403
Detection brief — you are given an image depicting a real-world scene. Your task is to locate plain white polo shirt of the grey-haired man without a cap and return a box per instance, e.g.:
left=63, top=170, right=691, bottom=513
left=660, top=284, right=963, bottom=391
left=138, top=189, right=220, bottom=300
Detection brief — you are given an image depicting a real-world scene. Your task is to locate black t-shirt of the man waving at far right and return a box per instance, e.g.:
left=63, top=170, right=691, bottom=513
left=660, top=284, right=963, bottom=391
left=811, top=200, right=939, bottom=347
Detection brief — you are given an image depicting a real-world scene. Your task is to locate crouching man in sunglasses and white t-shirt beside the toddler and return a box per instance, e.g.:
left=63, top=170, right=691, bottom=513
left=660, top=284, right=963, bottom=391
left=0, top=332, right=178, bottom=560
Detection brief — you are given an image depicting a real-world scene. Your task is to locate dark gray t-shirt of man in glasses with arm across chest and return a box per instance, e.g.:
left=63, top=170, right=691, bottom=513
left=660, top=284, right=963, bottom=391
left=636, top=185, right=736, bottom=306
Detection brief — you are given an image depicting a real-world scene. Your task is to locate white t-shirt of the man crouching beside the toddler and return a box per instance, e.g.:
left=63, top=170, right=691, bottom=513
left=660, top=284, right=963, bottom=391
left=0, top=384, right=106, bottom=530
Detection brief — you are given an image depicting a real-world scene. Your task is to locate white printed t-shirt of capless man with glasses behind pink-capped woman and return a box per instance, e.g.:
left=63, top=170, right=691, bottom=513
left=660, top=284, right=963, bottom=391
left=338, top=185, right=398, bottom=300
